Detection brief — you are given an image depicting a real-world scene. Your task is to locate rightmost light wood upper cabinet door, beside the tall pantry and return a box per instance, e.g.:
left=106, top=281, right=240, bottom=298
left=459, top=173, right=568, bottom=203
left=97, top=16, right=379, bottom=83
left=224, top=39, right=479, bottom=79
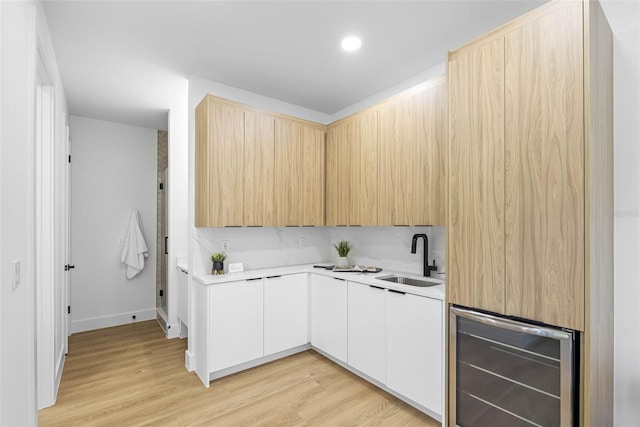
left=412, top=81, right=448, bottom=225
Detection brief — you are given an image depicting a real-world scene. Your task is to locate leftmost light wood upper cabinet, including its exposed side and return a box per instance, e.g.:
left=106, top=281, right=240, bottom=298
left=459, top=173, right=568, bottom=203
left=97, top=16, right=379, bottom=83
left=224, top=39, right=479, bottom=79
left=195, top=97, right=244, bottom=227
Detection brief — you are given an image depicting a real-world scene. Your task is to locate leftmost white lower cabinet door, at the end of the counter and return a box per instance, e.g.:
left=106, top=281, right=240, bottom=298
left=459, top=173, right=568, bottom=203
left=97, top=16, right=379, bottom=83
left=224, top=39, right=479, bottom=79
left=209, top=279, right=263, bottom=372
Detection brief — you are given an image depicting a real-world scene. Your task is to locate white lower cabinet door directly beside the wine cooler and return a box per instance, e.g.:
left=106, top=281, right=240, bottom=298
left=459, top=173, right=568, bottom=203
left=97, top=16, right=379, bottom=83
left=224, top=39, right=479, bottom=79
left=387, top=291, right=444, bottom=415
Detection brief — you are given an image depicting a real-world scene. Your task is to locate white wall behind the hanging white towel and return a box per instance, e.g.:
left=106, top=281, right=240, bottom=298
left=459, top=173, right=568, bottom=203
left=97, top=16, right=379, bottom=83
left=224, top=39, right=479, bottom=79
left=70, top=116, right=157, bottom=332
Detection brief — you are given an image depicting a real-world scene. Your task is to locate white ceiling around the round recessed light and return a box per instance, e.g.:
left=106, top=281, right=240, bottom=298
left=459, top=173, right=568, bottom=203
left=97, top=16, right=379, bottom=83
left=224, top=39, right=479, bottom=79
left=44, top=0, right=560, bottom=129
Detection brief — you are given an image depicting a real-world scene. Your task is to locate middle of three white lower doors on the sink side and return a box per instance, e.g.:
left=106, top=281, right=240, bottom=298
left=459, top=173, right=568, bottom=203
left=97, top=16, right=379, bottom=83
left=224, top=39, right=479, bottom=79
left=348, top=282, right=387, bottom=383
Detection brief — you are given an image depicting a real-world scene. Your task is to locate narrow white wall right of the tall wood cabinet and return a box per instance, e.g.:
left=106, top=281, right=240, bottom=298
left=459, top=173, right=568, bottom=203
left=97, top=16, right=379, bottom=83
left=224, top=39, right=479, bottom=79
left=605, top=7, right=640, bottom=427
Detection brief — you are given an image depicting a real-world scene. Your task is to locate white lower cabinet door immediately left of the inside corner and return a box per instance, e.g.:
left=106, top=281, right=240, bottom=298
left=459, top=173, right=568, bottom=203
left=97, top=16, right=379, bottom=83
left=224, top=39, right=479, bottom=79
left=264, top=273, right=309, bottom=356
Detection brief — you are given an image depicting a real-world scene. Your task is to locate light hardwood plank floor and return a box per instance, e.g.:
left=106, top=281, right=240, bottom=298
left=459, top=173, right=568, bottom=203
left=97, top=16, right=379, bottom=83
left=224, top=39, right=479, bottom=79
left=39, top=321, right=440, bottom=426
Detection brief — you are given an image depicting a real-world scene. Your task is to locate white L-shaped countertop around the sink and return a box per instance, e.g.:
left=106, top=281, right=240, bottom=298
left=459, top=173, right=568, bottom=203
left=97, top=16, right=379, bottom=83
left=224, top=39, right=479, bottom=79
left=193, top=263, right=445, bottom=301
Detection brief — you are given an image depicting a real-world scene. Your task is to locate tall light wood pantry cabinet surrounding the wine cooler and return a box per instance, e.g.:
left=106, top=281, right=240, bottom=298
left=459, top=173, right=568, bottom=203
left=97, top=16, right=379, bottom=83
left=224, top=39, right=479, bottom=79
left=447, top=1, right=613, bottom=426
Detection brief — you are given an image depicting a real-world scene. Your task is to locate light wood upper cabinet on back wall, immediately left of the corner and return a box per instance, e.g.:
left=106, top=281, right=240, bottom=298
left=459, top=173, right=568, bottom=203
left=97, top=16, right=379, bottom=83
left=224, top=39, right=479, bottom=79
left=275, top=119, right=325, bottom=227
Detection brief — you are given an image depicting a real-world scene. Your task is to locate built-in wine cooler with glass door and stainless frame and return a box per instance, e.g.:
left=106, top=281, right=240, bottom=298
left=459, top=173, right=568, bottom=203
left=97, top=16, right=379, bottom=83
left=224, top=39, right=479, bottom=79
left=449, top=306, right=578, bottom=427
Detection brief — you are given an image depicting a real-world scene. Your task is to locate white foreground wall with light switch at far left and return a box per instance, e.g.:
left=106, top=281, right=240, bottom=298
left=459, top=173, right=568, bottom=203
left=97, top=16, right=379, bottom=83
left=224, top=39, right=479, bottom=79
left=0, top=2, right=36, bottom=425
